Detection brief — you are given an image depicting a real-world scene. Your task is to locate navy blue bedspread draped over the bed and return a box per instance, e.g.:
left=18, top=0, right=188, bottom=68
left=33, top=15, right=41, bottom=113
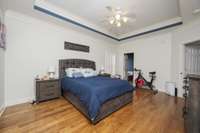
left=61, top=76, right=133, bottom=120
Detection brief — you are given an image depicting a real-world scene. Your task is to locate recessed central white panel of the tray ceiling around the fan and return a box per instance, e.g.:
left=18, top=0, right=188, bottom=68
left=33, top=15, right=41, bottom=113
left=46, top=0, right=180, bottom=36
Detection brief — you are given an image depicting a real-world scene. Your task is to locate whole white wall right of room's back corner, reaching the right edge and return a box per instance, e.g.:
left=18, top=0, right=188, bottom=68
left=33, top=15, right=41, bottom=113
left=117, top=19, right=200, bottom=97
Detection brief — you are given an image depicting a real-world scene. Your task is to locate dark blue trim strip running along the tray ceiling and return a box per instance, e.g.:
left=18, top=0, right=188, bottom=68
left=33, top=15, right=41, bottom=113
left=33, top=5, right=183, bottom=41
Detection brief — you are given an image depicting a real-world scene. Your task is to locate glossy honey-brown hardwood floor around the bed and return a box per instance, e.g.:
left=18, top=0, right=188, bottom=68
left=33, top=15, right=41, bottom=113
left=0, top=90, right=184, bottom=133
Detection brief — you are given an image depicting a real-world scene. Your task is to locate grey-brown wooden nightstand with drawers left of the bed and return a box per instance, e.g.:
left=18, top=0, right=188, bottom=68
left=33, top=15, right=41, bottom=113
left=36, top=79, right=61, bottom=103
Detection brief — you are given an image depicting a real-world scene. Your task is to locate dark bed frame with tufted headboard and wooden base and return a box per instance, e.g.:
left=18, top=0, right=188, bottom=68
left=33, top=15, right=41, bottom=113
left=59, top=59, right=133, bottom=124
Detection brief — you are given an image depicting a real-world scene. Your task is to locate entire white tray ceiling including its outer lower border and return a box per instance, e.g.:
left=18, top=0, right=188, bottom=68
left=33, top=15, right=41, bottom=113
left=0, top=0, right=200, bottom=39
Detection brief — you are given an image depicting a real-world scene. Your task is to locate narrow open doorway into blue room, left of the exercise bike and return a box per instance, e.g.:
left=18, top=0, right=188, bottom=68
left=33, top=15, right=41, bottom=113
left=124, top=53, right=134, bottom=83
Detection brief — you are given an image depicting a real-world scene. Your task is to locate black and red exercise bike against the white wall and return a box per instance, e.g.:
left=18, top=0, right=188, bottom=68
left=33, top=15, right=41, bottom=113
left=134, top=68, right=158, bottom=94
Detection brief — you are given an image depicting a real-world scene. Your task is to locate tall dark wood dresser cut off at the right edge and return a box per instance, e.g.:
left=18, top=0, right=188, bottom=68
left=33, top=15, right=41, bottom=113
left=183, top=75, right=200, bottom=133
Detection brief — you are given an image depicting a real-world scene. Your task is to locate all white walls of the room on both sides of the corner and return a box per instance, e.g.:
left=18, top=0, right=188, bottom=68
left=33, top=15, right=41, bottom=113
left=3, top=7, right=200, bottom=106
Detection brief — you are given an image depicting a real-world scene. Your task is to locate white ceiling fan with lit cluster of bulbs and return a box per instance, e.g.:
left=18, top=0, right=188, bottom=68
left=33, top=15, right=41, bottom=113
left=106, top=6, right=136, bottom=27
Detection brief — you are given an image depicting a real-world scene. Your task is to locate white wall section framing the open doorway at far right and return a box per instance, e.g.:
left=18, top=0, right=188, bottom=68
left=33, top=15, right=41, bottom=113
left=171, top=19, right=200, bottom=96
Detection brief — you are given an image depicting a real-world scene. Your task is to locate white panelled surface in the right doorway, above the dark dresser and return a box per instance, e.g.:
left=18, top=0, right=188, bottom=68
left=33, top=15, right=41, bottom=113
left=185, top=47, right=200, bottom=75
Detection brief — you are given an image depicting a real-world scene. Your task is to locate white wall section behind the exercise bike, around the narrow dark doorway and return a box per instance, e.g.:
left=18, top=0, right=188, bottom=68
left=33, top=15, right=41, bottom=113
left=117, top=32, right=171, bottom=91
